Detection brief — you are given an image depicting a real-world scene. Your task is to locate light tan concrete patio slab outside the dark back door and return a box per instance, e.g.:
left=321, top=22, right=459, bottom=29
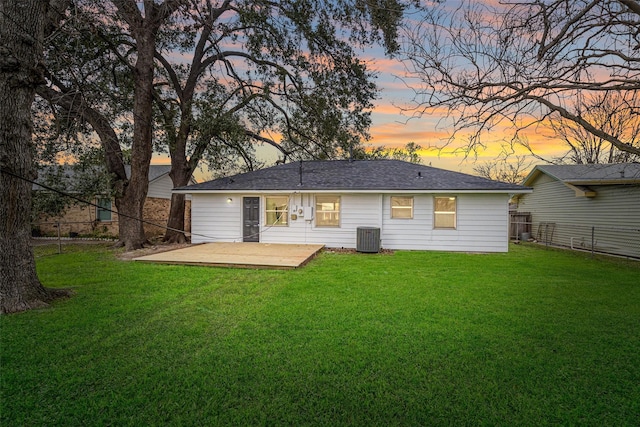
left=133, top=242, right=324, bottom=269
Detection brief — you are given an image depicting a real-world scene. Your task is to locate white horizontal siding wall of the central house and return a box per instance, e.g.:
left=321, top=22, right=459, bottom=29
left=192, top=194, right=509, bottom=252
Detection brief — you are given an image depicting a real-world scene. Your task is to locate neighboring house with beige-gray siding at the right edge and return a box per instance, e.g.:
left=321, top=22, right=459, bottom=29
left=518, top=163, right=640, bottom=257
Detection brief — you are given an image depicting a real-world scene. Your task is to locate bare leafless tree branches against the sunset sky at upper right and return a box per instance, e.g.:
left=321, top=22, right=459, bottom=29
left=403, top=0, right=640, bottom=161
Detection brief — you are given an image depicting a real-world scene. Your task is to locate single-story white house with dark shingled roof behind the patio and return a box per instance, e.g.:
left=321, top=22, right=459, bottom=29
left=174, top=160, right=530, bottom=252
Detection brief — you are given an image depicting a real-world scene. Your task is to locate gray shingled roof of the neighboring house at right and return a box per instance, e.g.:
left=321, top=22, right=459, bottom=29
left=525, top=163, right=640, bottom=184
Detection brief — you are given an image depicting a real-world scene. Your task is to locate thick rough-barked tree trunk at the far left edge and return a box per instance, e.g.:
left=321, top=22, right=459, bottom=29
left=0, top=0, right=69, bottom=313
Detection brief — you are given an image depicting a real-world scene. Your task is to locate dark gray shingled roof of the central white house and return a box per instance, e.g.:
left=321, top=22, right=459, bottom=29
left=174, top=160, right=529, bottom=193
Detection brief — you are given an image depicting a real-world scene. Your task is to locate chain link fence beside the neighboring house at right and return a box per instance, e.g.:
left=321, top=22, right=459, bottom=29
left=509, top=216, right=640, bottom=259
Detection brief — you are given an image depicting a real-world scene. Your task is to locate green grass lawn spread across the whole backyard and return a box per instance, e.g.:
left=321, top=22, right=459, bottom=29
left=0, top=245, right=640, bottom=426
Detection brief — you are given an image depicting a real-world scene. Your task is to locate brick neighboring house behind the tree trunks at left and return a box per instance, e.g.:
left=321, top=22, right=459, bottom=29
left=34, top=165, right=196, bottom=237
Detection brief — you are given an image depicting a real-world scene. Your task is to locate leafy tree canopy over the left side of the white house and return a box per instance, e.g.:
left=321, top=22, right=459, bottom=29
left=39, top=0, right=405, bottom=246
